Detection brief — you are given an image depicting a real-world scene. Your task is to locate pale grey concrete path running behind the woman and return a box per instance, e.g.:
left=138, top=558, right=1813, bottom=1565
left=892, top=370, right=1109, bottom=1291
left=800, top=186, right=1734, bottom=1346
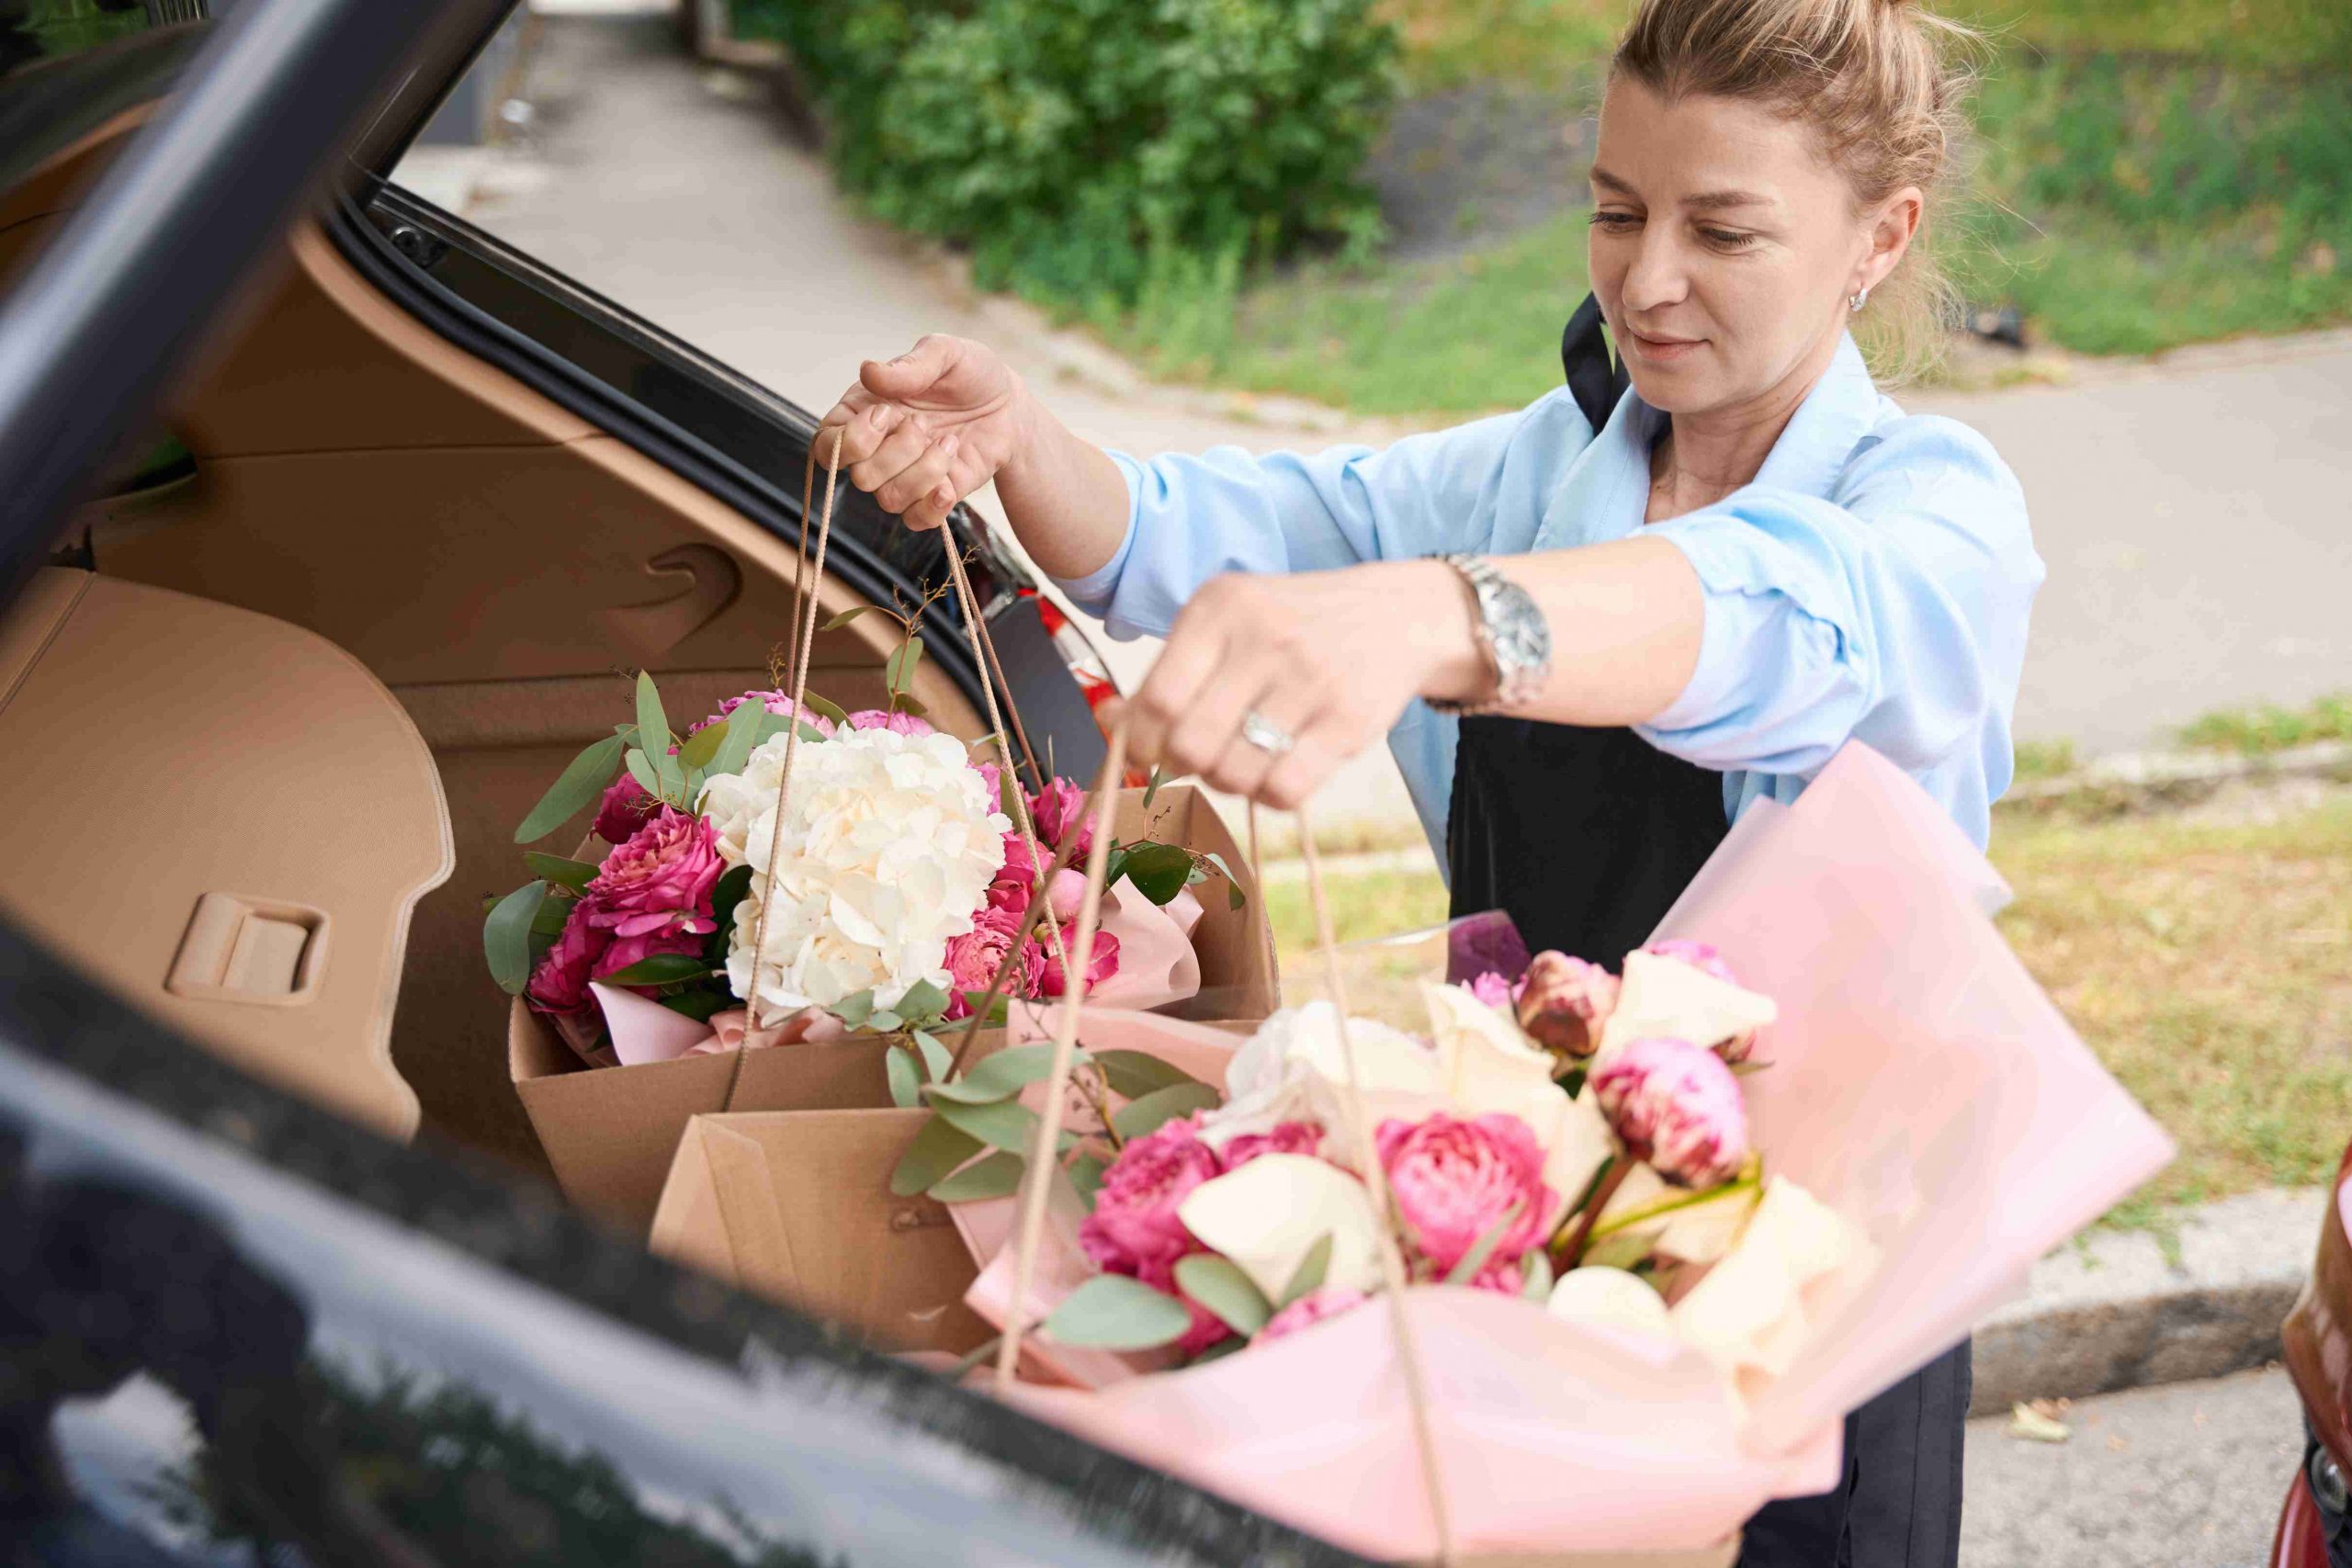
left=404, top=14, right=2352, bottom=823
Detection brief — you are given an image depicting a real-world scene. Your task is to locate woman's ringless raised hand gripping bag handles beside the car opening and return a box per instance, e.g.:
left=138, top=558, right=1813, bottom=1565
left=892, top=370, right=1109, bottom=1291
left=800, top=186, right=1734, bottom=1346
left=816, top=333, right=1030, bottom=529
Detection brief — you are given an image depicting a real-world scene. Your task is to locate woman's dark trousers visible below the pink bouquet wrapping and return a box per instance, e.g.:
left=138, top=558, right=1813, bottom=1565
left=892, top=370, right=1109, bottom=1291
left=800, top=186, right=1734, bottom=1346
left=1738, top=1342, right=1971, bottom=1568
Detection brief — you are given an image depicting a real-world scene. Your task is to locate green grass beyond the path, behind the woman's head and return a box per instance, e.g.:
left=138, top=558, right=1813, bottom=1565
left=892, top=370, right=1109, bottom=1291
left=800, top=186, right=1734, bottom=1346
left=1101, top=0, right=2352, bottom=413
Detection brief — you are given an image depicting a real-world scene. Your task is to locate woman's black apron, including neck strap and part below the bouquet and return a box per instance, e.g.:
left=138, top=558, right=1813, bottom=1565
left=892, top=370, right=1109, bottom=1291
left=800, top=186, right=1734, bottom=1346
left=1446, top=299, right=1969, bottom=1568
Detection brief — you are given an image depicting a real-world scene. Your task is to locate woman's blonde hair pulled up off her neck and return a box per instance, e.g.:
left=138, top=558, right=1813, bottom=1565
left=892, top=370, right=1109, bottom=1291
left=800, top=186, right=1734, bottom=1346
left=1611, top=0, right=1983, bottom=381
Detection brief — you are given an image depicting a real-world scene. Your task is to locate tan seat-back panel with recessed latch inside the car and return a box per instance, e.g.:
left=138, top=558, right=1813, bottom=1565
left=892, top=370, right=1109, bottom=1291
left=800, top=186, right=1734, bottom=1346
left=0, top=569, right=452, bottom=1135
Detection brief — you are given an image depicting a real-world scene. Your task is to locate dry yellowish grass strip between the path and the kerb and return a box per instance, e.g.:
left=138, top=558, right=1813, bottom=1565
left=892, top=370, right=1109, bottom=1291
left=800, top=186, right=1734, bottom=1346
left=1268, top=797, right=2352, bottom=1227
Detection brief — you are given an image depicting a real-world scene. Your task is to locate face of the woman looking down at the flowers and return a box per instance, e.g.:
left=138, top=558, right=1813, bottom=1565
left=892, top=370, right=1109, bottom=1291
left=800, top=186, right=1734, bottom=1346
left=1590, top=77, right=1917, bottom=413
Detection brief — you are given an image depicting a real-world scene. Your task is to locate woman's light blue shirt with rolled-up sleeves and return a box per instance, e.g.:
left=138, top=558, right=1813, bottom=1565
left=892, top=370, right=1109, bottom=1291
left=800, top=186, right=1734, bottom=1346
left=1063, top=339, right=2041, bottom=863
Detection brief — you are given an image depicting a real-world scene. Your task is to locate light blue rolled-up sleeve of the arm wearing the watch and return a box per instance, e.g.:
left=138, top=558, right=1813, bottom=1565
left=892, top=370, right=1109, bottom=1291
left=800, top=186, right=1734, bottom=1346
left=1642, top=416, right=2041, bottom=799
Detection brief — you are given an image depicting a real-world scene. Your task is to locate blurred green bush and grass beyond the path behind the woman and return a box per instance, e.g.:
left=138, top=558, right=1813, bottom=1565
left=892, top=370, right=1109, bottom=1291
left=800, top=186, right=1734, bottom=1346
left=734, top=0, right=2352, bottom=413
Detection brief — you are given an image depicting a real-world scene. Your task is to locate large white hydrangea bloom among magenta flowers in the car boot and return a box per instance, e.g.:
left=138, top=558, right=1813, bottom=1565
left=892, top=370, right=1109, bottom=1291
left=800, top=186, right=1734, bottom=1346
left=701, top=728, right=1012, bottom=1022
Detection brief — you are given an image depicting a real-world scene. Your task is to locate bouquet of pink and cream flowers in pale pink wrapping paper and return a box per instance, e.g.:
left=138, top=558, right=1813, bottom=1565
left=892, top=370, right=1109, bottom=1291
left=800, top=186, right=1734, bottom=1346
left=922, top=745, right=2171, bottom=1559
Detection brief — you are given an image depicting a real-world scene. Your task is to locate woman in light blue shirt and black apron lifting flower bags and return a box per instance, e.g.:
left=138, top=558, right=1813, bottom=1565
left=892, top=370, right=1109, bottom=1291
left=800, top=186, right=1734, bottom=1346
left=820, top=0, right=2041, bottom=1568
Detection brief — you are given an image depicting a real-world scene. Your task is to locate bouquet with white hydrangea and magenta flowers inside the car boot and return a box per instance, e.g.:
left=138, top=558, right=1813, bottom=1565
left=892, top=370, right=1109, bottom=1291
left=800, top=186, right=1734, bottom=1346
left=484, top=662, right=1239, bottom=1086
